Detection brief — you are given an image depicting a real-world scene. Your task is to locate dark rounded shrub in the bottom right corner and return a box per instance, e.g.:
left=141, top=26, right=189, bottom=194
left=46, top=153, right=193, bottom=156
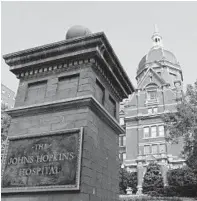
left=164, top=167, right=197, bottom=197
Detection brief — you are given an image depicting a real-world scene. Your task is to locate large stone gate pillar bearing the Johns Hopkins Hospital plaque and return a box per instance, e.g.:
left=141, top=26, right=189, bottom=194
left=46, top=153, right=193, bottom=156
left=2, top=27, right=134, bottom=201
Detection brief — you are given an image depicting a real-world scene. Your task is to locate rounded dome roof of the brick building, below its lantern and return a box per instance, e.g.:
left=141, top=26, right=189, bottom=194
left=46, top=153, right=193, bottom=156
left=137, top=47, right=178, bottom=73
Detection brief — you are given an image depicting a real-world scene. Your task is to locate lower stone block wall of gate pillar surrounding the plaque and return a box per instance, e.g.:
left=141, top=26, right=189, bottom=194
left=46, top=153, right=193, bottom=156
left=2, top=103, right=118, bottom=201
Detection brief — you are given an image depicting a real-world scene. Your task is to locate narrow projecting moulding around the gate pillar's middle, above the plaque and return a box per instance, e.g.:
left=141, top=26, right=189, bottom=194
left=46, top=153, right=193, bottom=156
left=6, top=95, right=125, bottom=134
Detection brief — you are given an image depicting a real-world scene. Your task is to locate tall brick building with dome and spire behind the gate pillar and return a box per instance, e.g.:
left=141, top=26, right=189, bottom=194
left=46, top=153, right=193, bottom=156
left=119, top=27, right=184, bottom=192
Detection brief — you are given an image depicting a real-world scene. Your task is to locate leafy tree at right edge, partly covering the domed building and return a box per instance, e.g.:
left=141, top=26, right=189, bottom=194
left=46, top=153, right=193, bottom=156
left=163, top=80, right=197, bottom=171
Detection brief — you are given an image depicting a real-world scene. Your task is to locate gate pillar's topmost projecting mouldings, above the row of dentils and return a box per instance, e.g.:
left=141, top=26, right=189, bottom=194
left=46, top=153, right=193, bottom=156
left=3, top=32, right=135, bottom=98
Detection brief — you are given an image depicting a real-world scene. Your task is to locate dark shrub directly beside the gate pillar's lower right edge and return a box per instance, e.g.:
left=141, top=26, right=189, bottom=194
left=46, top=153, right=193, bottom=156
left=119, top=167, right=137, bottom=194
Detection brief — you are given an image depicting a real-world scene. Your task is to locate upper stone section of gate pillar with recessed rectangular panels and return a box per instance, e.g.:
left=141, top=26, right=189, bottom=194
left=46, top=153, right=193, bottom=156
left=15, top=63, right=119, bottom=119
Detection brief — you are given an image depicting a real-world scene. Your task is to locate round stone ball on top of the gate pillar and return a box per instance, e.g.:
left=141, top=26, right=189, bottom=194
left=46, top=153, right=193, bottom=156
left=66, top=25, right=91, bottom=39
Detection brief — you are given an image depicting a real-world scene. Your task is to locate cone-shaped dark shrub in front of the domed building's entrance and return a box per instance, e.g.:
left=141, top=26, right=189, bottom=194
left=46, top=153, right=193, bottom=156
left=142, top=162, right=164, bottom=196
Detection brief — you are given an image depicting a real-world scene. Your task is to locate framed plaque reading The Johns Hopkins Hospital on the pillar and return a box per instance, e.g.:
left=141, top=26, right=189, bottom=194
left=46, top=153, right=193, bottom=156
left=2, top=128, right=82, bottom=193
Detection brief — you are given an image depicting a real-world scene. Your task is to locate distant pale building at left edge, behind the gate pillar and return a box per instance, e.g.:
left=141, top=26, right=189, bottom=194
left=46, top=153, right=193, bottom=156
left=1, top=84, right=15, bottom=108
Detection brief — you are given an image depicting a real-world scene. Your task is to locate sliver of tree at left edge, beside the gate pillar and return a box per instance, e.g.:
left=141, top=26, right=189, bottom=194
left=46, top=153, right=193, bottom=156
left=1, top=103, right=11, bottom=156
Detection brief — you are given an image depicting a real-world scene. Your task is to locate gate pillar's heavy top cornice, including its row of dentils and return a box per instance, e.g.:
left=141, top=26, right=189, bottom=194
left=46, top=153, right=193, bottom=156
left=3, top=32, right=134, bottom=98
